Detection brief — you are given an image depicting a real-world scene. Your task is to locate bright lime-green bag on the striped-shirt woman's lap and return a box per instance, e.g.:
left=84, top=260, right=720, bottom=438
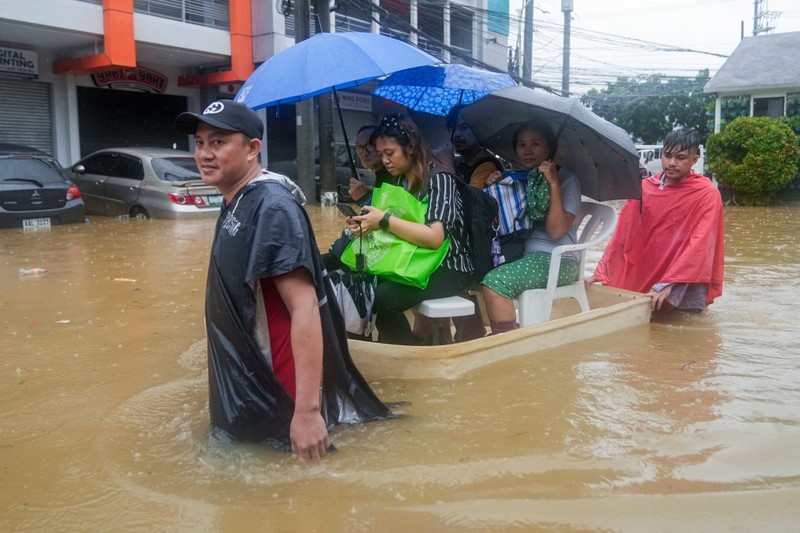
left=342, top=183, right=450, bottom=289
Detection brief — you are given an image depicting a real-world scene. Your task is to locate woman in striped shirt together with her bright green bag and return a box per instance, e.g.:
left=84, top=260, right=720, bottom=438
left=343, top=114, right=473, bottom=344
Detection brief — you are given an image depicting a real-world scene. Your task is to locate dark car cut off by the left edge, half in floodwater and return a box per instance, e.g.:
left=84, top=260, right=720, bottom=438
left=0, top=143, right=86, bottom=229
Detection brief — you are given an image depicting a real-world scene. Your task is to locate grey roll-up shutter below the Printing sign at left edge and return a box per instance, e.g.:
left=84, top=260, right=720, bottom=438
left=0, top=80, right=53, bottom=154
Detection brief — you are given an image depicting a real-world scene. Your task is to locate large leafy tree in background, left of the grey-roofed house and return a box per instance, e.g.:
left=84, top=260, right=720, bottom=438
left=581, top=69, right=714, bottom=144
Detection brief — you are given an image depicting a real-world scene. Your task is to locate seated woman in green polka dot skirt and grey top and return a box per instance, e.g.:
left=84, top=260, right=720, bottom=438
left=482, top=122, right=581, bottom=334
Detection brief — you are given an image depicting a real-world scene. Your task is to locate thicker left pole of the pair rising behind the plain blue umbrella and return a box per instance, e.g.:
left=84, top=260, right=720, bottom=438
left=294, top=0, right=317, bottom=202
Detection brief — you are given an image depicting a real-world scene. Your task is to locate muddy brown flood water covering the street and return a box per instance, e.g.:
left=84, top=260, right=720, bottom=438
left=0, top=206, right=800, bottom=532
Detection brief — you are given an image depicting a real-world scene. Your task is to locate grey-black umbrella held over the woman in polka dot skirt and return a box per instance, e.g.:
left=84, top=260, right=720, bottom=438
left=461, top=86, right=641, bottom=201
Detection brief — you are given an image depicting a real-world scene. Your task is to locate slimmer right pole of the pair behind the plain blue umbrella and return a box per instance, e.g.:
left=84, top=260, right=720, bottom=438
left=314, top=0, right=336, bottom=205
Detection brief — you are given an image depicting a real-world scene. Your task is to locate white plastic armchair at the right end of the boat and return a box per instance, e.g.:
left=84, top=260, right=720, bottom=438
left=516, top=202, right=617, bottom=326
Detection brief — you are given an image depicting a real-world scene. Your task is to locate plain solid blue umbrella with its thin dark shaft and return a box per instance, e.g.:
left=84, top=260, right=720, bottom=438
left=235, top=32, right=439, bottom=179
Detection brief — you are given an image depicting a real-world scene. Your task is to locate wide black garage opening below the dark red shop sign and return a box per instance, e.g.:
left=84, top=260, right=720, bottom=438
left=78, top=87, right=189, bottom=157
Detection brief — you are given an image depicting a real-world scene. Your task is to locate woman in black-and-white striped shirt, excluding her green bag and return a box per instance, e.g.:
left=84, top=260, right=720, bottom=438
left=350, top=114, right=473, bottom=344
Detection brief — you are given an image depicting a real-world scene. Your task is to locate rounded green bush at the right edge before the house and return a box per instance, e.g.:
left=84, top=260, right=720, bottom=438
left=706, top=117, right=798, bottom=205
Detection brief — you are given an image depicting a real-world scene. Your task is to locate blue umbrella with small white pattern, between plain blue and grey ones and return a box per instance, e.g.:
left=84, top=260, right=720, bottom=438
left=372, top=65, right=516, bottom=116
